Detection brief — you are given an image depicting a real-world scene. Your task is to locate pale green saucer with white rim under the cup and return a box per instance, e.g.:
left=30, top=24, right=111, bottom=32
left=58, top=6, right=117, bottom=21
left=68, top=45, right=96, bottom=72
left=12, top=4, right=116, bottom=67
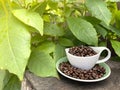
left=56, top=57, right=111, bottom=82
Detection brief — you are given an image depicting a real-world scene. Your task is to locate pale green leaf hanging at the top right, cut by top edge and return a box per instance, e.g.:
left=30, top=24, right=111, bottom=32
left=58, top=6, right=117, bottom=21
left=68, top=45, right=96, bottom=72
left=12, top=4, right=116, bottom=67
left=85, top=0, right=112, bottom=25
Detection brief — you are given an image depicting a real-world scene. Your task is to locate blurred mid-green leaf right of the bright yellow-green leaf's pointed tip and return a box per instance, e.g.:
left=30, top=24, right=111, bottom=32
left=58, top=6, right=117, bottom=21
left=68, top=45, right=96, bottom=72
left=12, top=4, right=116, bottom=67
left=44, top=23, right=64, bottom=36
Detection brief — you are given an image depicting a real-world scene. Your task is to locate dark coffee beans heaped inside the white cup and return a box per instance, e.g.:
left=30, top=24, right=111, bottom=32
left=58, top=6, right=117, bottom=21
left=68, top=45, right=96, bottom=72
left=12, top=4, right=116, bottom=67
left=69, top=46, right=97, bottom=57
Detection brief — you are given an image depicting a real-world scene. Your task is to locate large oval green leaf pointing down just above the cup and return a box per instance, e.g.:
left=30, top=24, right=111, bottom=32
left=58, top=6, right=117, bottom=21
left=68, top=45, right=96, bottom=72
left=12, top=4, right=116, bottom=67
left=67, top=18, right=98, bottom=45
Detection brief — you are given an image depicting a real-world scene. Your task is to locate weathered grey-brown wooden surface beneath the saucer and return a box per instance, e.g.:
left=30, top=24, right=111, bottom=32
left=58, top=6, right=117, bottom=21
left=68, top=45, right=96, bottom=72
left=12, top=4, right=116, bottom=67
left=21, top=60, right=120, bottom=90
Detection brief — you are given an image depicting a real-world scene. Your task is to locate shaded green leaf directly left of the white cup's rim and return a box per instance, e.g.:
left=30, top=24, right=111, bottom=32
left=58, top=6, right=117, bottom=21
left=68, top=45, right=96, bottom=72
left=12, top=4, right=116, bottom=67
left=54, top=44, right=65, bottom=61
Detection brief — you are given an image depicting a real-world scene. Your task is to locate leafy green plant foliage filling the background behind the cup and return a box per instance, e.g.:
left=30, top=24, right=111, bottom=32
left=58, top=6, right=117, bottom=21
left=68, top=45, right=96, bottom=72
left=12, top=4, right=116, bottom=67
left=0, top=0, right=120, bottom=90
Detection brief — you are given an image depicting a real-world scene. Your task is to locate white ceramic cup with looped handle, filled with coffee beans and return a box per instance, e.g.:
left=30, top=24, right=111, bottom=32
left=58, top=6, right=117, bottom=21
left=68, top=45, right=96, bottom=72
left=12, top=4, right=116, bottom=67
left=65, top=47, right=111, bottom=70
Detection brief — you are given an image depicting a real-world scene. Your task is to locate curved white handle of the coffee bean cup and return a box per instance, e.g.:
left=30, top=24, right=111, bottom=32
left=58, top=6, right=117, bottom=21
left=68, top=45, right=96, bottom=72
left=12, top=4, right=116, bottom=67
left=96, top=47, right=111, bottom=64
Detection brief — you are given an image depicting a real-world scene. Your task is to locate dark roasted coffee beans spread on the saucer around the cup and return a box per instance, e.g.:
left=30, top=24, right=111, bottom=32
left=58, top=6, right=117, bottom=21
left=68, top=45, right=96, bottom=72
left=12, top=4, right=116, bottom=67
left=59, top=62, right=106, bottom=80
